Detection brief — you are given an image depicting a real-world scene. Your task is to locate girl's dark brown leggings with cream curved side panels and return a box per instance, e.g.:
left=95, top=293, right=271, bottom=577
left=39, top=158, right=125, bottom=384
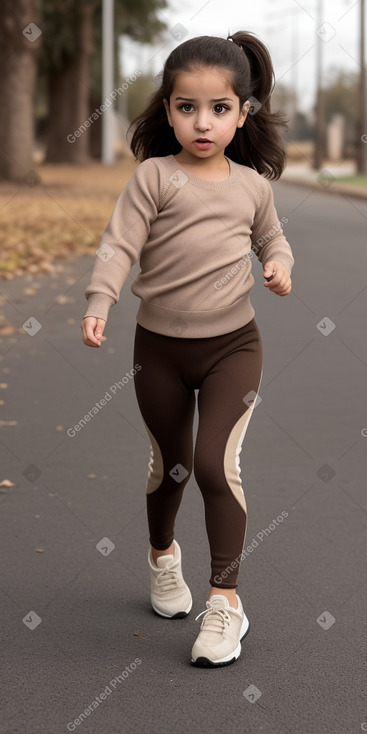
left=134, top=318, right=263, bottom=589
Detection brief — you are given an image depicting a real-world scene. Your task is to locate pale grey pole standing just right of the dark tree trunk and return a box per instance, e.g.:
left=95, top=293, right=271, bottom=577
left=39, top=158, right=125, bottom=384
left=102, top=0, right=115, bottom=163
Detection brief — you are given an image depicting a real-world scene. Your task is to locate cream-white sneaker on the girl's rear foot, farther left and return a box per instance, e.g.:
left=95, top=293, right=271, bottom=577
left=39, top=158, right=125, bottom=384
left=148, top=540, right=192, bottom=619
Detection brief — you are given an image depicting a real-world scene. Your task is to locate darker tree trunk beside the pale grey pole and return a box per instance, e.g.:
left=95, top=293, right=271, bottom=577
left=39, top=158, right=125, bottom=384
left=46, top=0, right=94, bottom=164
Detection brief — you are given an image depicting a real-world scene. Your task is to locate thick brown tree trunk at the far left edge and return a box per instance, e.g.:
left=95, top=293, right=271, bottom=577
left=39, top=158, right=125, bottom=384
left=0, top=0, right=42, bottom=185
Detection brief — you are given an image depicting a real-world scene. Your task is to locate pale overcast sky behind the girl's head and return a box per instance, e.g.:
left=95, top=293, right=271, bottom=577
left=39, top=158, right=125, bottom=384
left=122, top=0, right=361, bottom=111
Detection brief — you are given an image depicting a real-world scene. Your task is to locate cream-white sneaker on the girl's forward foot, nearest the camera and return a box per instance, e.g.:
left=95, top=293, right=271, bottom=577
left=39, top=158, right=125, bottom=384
left=191, top=594, right=250, bottom=668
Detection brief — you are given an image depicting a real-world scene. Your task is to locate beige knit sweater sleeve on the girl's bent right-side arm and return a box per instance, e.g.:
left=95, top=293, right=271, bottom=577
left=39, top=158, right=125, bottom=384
left=251, top=176, right=294, bottom=273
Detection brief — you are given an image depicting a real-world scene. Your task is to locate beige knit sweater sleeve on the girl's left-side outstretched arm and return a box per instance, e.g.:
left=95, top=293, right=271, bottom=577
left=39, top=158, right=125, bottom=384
left=84, top=159, right=160, bottom=321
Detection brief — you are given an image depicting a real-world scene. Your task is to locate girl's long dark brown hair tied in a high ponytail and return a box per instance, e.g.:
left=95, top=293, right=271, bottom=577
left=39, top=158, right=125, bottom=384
left=129, top=31, right=287, bottom=179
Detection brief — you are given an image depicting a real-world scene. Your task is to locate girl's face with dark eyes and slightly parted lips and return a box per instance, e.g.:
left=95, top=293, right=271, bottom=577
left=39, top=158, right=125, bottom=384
left=164, top=68, right=251, bottom=164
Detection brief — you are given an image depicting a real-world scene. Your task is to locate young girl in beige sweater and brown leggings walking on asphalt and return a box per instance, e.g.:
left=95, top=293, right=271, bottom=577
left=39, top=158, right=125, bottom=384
left=82, top=31, right=294, bottom=667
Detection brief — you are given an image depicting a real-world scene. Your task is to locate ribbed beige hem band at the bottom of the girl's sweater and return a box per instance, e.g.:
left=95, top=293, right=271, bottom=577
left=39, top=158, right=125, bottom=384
left=136, top=296, right=255, bottom=339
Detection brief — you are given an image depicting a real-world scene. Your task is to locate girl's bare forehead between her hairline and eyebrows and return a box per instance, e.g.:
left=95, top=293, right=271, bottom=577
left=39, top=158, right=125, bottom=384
left=172, top=68, right=236, bottom=97
